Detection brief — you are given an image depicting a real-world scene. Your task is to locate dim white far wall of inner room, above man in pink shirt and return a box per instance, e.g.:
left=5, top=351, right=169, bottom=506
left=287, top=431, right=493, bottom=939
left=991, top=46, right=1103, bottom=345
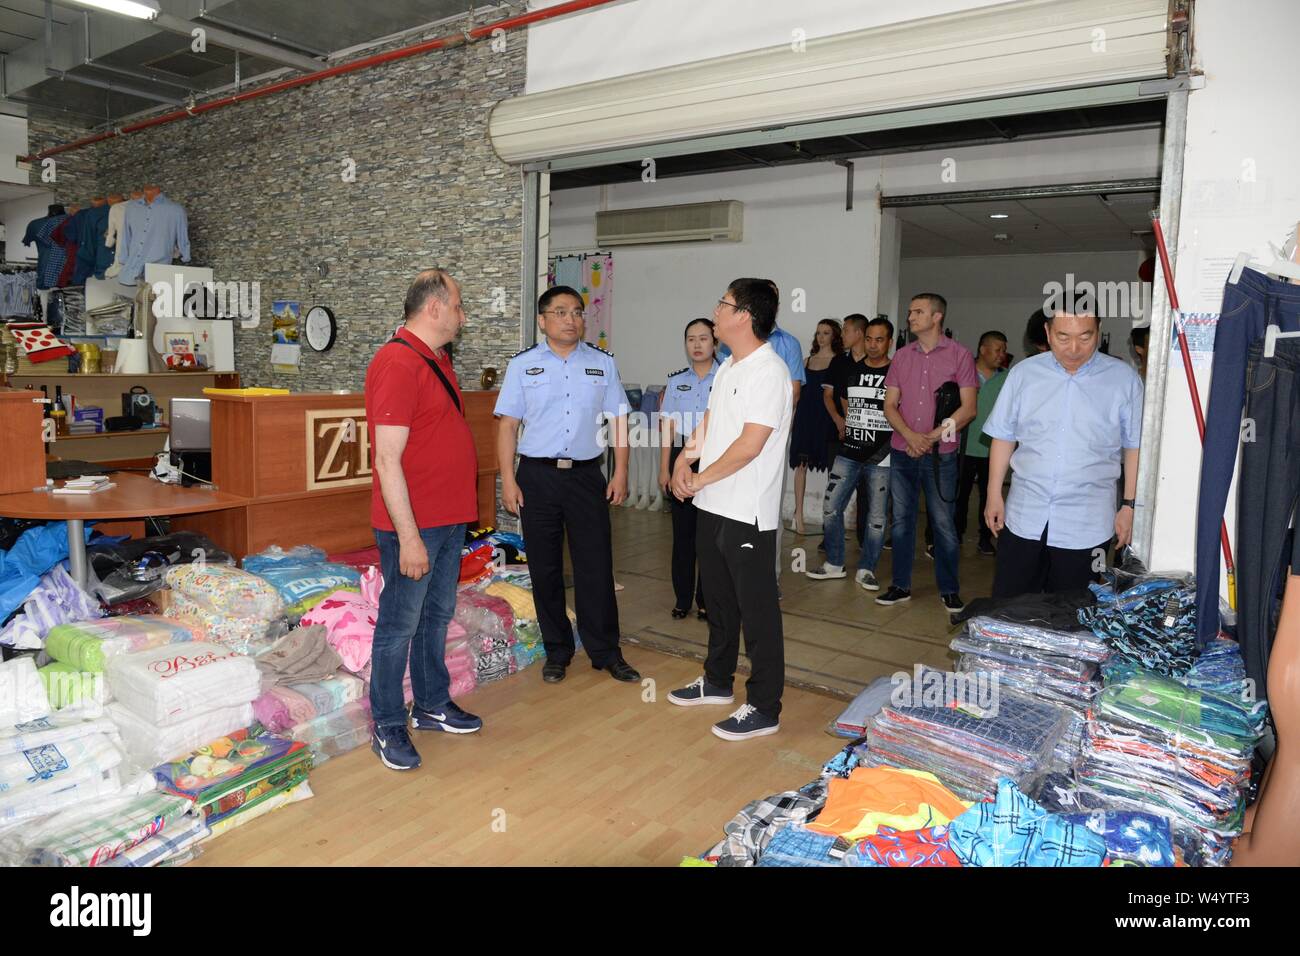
left=904, top=251, right=1145, bottom=359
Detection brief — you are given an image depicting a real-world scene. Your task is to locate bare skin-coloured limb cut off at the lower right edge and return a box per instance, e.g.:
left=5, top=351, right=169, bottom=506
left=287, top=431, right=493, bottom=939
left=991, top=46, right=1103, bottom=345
left=1231, top=575, right=1300, bottom=866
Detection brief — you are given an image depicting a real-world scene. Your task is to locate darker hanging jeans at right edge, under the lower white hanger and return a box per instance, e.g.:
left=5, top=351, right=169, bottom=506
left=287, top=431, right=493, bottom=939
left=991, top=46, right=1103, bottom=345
left=1236, top=338, right=1300, bottom=700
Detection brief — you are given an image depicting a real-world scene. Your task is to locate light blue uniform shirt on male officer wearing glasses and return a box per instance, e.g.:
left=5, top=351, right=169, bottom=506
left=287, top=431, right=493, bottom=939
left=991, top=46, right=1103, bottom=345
left=494, top=338, right=628, bottom=462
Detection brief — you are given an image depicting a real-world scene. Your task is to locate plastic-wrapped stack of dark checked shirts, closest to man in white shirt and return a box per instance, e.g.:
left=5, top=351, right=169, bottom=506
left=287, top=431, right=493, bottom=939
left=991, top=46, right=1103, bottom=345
left=866, top=670, right=1070, bottom=800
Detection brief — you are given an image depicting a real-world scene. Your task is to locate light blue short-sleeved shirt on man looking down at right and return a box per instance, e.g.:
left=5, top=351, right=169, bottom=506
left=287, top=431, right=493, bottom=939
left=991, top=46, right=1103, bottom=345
left=984, top=351, right=1143, bottom=549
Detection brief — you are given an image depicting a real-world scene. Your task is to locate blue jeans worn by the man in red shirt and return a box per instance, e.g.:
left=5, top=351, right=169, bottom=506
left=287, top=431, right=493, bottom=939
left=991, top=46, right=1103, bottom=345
left=371, top=524, right=465, bottom=727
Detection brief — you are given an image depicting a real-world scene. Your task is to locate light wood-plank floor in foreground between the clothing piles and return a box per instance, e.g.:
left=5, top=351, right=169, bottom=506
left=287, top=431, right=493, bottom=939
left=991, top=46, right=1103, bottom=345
left=195, top=646, right=842, bottom=866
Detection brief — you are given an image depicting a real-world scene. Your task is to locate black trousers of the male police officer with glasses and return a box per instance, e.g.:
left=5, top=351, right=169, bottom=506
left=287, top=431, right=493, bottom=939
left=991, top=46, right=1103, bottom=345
left=515, top=458, right=620, bottom=667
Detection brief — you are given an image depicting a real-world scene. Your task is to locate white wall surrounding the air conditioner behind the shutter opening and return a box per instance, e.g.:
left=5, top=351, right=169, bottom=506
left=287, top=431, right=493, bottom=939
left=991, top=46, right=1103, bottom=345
left=550, top=164, right=880, bottom=385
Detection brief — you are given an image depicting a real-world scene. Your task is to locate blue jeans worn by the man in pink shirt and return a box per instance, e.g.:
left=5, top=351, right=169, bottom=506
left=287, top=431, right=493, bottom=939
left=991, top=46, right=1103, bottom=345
left=889, top=449, right=959, bottom=594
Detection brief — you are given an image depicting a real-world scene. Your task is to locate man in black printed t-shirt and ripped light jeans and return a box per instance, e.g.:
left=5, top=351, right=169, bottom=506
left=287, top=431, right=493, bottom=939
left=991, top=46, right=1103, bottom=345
left=807, top=315, right=893, bottom=591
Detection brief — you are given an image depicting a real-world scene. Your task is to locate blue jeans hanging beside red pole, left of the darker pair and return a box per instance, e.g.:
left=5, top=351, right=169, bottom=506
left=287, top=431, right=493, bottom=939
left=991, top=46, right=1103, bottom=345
left=1196, top=269, right=1300, bottom=647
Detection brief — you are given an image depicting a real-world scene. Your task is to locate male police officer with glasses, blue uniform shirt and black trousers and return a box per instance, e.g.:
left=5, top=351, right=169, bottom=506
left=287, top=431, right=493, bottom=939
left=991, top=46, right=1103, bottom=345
left=495, top=286, right=641, bottom=683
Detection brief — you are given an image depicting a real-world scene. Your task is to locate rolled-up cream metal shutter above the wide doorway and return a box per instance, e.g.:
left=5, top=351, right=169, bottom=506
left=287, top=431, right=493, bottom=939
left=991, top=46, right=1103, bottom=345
left=489, top=0, right=1169, bottom=163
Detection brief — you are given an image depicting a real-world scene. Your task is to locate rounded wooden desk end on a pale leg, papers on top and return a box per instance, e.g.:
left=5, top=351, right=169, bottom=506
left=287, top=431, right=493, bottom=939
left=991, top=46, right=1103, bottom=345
left=0, top=472, right=247, bottom=588
